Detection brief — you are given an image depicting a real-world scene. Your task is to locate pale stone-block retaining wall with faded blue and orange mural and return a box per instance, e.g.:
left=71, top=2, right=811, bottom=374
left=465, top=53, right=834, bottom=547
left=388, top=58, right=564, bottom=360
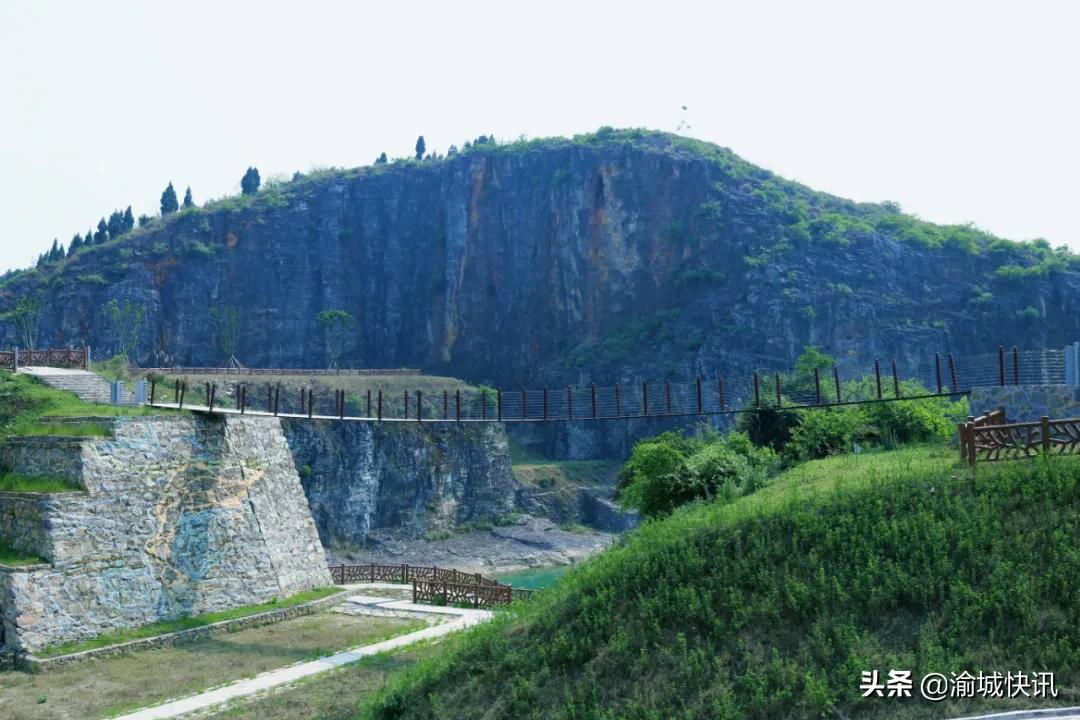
left=0, top=418, right=332, bottom=651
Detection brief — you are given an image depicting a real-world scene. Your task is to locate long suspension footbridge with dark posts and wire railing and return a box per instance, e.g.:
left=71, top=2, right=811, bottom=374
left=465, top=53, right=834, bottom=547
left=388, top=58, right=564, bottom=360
left=143, top=348, right=1065, bottom=422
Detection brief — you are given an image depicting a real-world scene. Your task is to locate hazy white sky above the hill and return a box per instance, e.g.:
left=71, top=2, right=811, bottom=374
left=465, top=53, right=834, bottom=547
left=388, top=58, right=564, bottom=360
left=0, top=0, right=1080, bottom=271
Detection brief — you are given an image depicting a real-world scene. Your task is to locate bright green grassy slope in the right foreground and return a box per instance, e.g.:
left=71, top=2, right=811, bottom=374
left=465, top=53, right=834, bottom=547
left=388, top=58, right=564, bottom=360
left=362, top=448, right=1080, bottom=720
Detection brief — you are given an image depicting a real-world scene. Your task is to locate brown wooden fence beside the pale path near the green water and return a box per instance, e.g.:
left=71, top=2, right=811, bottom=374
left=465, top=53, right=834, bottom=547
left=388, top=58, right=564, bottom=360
left=329, top=562, right=536, bottom=608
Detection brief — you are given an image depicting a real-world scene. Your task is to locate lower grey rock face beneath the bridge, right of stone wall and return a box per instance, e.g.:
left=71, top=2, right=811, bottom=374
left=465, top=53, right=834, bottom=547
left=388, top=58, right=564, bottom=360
left=282, top=420, right=516, bottom=545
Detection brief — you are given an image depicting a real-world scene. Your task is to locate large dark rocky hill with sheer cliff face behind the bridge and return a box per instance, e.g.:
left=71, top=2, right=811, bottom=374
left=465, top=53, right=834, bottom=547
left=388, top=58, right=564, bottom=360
left=0, top=128, right=1080, bottom=384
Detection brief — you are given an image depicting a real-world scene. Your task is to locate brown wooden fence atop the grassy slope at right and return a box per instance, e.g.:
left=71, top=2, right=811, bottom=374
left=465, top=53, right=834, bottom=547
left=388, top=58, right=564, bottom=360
left=959, top=409, right=1080, bottom=465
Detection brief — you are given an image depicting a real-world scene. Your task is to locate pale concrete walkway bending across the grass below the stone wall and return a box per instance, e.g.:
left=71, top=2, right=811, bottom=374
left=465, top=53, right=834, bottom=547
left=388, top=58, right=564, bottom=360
left=119, top=583, right=491, bottom=720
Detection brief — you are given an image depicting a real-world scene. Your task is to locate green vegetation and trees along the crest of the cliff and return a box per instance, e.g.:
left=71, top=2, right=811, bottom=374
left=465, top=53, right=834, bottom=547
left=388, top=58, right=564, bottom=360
left=0, top=127, right=1080, bottom=293
